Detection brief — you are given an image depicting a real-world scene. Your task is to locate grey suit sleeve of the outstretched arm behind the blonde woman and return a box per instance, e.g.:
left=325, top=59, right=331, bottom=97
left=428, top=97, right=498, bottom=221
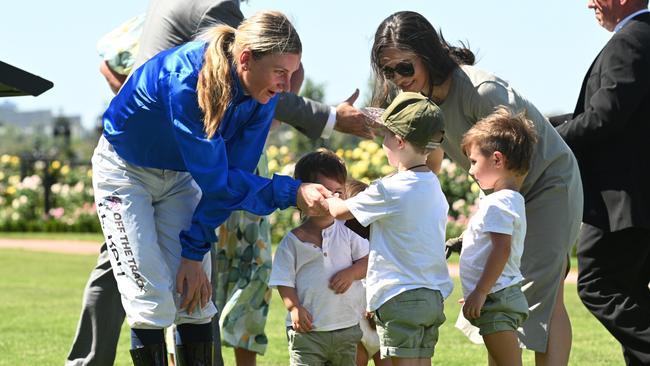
left=275, top=93, right=330, bottom=139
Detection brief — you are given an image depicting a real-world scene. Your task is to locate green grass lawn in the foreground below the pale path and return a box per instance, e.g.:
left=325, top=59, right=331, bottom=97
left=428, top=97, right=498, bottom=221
left=0, top=250, right=623, bottom=366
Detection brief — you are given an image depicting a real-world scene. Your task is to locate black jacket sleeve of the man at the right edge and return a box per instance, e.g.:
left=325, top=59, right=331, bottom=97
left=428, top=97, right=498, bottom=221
left=556, top=34, right=650, bottom=149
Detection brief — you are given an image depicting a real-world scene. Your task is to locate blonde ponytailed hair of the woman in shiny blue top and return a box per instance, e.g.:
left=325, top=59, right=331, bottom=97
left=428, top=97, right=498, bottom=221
left=196, top=11, right=302, bottom=138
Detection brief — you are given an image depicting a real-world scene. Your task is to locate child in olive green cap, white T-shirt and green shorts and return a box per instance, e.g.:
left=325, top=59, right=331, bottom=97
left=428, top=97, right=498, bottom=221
left=327, top=92, right=453, bottom=365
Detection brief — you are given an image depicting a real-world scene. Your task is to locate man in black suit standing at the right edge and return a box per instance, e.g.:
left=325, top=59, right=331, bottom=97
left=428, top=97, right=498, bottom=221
left=551, top=0, right=650, bottom=365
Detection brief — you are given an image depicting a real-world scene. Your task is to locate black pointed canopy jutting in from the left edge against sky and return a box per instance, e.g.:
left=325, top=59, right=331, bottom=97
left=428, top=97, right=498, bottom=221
left=0, top=61, right=54, bottom=98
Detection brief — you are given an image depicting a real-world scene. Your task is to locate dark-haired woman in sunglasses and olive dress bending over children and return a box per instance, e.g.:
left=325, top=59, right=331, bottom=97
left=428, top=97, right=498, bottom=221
left=371, top=11, right=583, bottom=365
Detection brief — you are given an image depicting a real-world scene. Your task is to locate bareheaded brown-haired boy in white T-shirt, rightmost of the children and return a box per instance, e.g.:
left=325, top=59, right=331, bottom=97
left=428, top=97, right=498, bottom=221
left=460, top=107, right=537, bottom=365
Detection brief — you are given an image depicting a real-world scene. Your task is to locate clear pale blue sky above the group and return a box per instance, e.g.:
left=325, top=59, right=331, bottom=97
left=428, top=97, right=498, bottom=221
left=0, top=0, right=611, bottom=130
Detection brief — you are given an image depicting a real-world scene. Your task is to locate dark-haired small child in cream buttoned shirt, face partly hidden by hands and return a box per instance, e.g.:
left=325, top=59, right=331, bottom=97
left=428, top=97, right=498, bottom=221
left=269, top=150, right=368, bottom=365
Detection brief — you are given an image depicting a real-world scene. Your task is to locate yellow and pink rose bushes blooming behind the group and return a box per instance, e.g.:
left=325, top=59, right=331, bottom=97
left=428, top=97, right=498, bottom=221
left=0, top=140, right=479, bottom=243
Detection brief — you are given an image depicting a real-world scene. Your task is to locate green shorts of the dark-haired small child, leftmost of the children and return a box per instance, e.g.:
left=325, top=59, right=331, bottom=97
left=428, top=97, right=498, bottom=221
left=287, top=324, right=361, bottom=366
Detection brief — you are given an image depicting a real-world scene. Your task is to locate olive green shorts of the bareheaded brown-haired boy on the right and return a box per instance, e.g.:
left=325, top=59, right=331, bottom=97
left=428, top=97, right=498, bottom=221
left=469, top=284, right=528, bottom=336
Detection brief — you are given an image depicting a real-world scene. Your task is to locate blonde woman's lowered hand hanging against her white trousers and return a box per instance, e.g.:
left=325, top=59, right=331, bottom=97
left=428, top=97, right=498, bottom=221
left=176, top=258, right=212, bottom=315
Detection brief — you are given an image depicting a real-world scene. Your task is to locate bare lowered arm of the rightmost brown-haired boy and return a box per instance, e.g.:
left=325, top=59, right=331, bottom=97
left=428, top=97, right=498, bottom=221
left=463, top=233, right=512, bottom=319
